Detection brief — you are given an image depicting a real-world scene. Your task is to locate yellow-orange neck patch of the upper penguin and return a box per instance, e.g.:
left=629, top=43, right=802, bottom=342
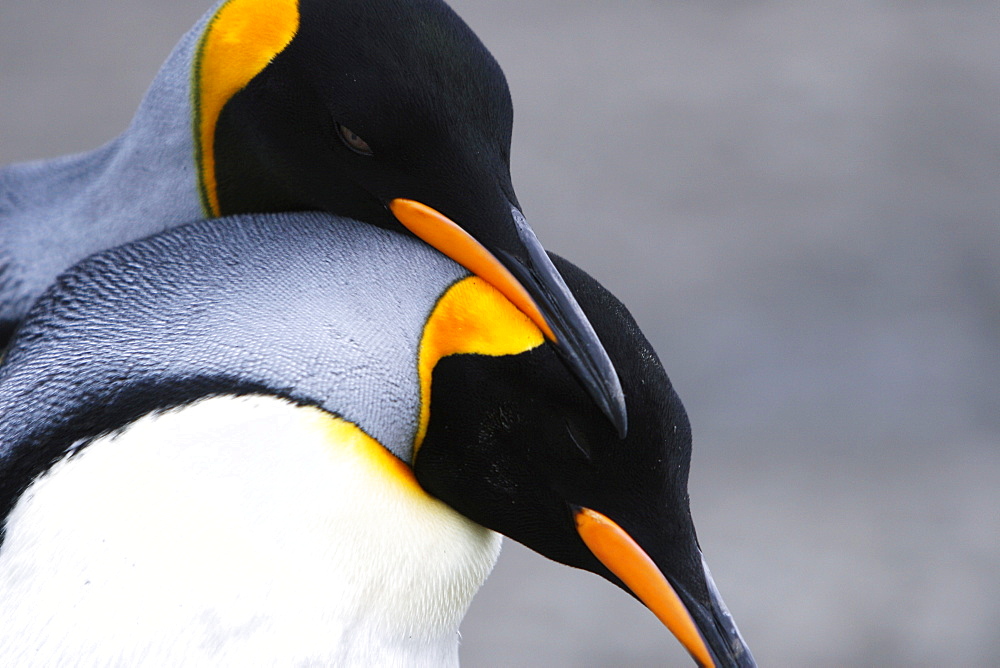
left=191, top=0, right=299, bottom=216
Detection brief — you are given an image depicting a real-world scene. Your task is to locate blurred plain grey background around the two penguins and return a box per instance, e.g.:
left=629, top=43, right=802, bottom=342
left=0, top=0, right=1000, bottom=666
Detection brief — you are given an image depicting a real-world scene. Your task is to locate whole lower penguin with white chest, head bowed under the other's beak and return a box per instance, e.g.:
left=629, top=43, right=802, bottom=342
left=0, top=213, right=753, bottom=666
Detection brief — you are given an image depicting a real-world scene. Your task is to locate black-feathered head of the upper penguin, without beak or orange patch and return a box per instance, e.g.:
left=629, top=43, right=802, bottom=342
left=210, top=0, right=516, bottom=232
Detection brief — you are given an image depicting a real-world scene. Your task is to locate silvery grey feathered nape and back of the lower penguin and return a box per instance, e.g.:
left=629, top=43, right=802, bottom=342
left=0, top=213, right=468, bottom=478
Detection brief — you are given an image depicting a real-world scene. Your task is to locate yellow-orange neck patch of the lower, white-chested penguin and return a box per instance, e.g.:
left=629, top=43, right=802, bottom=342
left=413, top=276, right=545, bottom=457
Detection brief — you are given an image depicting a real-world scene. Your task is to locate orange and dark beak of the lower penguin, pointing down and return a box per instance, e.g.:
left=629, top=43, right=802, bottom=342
left=574, top=508, right=757, bottom=668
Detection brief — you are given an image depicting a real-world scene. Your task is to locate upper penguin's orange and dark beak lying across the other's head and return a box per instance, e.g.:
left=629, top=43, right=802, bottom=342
left=389, top=198, right=628, bottom=438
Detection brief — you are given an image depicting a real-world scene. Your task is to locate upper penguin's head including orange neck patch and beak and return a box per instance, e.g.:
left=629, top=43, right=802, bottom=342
left=193, top=0, right=627, bottom=434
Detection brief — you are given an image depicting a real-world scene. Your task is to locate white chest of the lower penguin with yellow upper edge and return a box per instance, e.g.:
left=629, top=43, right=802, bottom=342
left=0, top=397, right=500, bottom=666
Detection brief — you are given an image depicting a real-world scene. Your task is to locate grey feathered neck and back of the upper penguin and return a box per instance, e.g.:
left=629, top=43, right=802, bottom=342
left=0, top=2, right=222, bottom=344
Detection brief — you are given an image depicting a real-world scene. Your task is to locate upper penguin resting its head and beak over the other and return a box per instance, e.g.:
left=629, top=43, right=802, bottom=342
left=0, top=0, right=627, bottom=435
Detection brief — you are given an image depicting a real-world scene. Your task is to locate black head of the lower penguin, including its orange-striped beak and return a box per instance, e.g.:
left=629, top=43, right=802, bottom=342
left=415, top=253, right=752, bottom=666
